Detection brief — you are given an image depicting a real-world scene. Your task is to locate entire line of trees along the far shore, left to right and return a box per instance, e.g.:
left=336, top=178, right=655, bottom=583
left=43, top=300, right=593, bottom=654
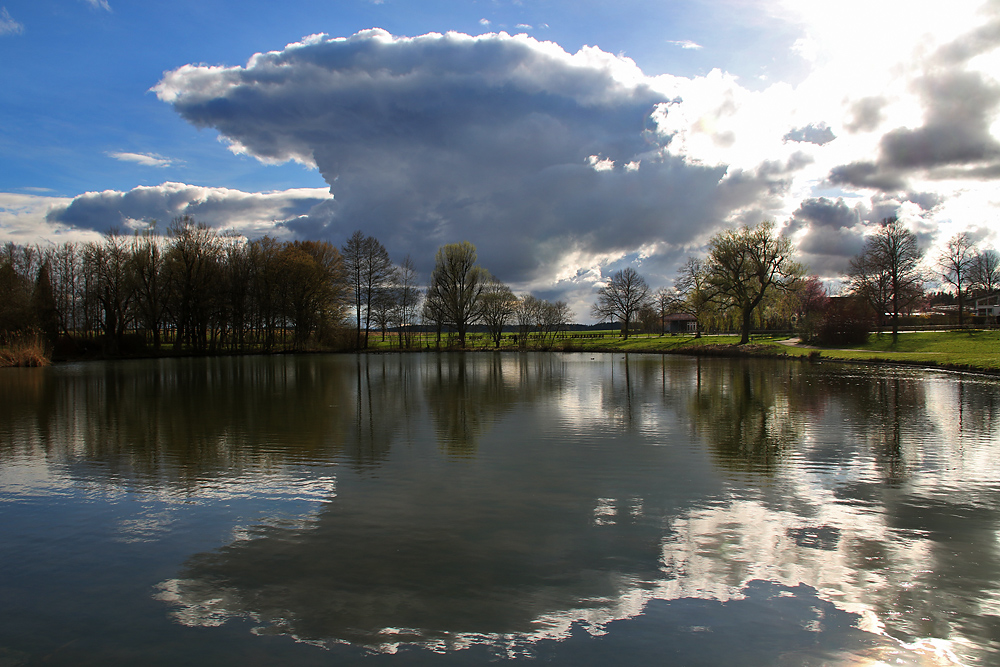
left=7, top=217, right=1000, bottom=356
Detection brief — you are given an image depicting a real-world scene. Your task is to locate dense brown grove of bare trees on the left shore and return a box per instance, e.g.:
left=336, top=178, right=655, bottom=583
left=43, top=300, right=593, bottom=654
left=0, top=217, right=345, bottom=355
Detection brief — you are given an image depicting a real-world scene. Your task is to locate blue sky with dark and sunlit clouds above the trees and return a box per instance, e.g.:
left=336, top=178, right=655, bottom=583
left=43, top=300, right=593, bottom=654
left=0, top=0, right=1000, bottom=321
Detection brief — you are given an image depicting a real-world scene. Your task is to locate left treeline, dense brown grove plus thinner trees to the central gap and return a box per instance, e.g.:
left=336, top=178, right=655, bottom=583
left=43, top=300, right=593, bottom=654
left=0, top=216, right=572, bottom=356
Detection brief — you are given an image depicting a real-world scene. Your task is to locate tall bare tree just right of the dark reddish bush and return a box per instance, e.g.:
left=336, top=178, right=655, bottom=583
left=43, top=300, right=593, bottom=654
left=848, top=216, right=924, bottom=340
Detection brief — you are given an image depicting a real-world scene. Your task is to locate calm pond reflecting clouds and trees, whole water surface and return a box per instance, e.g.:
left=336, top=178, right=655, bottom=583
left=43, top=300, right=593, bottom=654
left=0, top=354, right=1000, bottom=666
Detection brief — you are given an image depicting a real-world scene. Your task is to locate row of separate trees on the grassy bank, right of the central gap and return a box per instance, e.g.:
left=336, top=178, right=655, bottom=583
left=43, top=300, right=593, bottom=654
left=592, top=217, right=1000, bottom=345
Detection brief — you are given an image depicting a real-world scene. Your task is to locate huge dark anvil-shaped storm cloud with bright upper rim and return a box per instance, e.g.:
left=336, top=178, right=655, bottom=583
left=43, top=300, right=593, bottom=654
left=155, top=30, right=807, bottom=283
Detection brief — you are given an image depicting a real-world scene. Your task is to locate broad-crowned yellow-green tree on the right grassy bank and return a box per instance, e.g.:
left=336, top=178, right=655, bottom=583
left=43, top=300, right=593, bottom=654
left=706, top=220, right=802, bottom=345
